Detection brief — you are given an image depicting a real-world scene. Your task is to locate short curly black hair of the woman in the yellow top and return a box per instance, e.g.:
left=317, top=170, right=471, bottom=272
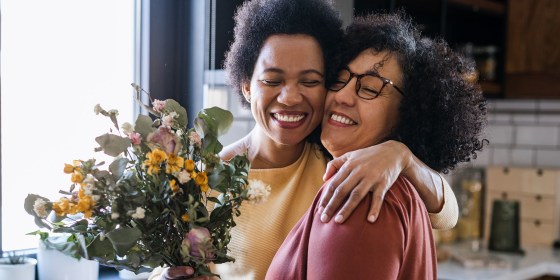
left=224, top=0, right=344, bottom=108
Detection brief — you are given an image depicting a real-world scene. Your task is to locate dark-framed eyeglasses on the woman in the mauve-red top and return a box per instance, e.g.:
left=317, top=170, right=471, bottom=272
left=329, top=67, right=404, bottom=100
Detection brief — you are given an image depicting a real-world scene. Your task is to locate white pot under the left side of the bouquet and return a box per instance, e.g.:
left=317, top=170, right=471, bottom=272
left=37, top=242, right=99, bottom=280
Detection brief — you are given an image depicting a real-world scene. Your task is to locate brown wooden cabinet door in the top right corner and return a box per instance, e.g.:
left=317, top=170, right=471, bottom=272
left=505, top=0, right=560, bottom=98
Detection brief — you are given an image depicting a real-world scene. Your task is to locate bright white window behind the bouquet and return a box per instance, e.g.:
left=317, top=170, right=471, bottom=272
left=0, top=0, right=134, bottom=250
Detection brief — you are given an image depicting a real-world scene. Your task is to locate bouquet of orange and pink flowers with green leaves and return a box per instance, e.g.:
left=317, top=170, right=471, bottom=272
left=25, top=84, right=269, bottom=275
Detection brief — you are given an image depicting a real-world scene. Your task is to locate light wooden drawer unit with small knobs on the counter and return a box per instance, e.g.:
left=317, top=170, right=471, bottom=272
left=484, top=166, right=560, bottom=248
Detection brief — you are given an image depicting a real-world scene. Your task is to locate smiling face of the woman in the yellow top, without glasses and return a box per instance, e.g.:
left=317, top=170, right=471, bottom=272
left=242, top=34, right=326, bottom=145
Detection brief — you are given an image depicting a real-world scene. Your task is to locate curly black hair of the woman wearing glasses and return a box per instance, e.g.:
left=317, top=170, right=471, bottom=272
left=339, top=10, right=488, bottom=173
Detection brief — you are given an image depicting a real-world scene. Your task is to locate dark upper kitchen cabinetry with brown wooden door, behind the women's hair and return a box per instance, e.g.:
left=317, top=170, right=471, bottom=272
left=354, top=0, right=560, bottom=98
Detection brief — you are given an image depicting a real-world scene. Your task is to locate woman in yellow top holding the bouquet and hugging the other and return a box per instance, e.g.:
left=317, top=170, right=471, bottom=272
left=154, top=0, right=457, bottom=279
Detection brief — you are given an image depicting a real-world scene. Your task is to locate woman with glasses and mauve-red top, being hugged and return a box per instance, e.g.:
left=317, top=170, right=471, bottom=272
left=266, top=11, right=486, bottom=279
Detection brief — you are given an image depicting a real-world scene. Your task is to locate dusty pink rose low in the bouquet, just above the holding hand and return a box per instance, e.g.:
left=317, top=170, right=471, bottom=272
left=181, top=227, right=215, bottom=261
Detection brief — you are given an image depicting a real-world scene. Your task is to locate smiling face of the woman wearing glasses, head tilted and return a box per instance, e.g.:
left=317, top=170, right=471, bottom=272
left=321, top=50, right=402, bottom=157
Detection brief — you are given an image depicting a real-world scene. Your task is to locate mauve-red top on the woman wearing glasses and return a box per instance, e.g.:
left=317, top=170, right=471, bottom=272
left=266, top=177, right=437, bottom=280
